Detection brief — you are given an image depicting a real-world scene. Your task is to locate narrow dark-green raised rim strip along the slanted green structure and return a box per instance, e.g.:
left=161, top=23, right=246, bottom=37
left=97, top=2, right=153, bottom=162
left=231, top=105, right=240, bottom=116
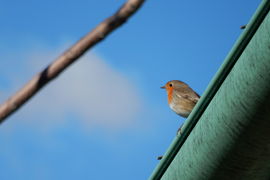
left=149, top=0, right=270, bottom=180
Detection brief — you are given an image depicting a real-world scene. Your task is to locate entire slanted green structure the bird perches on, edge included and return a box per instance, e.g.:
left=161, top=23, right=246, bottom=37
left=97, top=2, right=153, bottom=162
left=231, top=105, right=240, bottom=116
left=149, top=0, right=270, bottom=180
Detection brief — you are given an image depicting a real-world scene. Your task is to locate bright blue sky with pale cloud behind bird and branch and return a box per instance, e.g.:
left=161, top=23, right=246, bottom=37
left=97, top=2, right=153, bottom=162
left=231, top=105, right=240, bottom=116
left=0, top=0, right=260, bottom=180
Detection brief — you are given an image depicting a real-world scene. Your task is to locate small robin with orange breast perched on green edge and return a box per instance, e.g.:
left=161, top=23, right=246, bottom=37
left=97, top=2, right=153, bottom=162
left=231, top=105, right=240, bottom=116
left=161, top=80, right=200, bottom=130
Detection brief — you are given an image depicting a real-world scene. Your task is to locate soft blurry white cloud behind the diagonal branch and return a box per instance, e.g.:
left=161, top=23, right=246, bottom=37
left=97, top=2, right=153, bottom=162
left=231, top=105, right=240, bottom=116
left=1, top=45, right=141, bottom=129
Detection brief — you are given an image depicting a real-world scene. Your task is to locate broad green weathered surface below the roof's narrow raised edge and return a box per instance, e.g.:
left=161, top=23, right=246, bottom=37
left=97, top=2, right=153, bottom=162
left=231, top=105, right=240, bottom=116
left=162, top=4, right=270, bottom=180
